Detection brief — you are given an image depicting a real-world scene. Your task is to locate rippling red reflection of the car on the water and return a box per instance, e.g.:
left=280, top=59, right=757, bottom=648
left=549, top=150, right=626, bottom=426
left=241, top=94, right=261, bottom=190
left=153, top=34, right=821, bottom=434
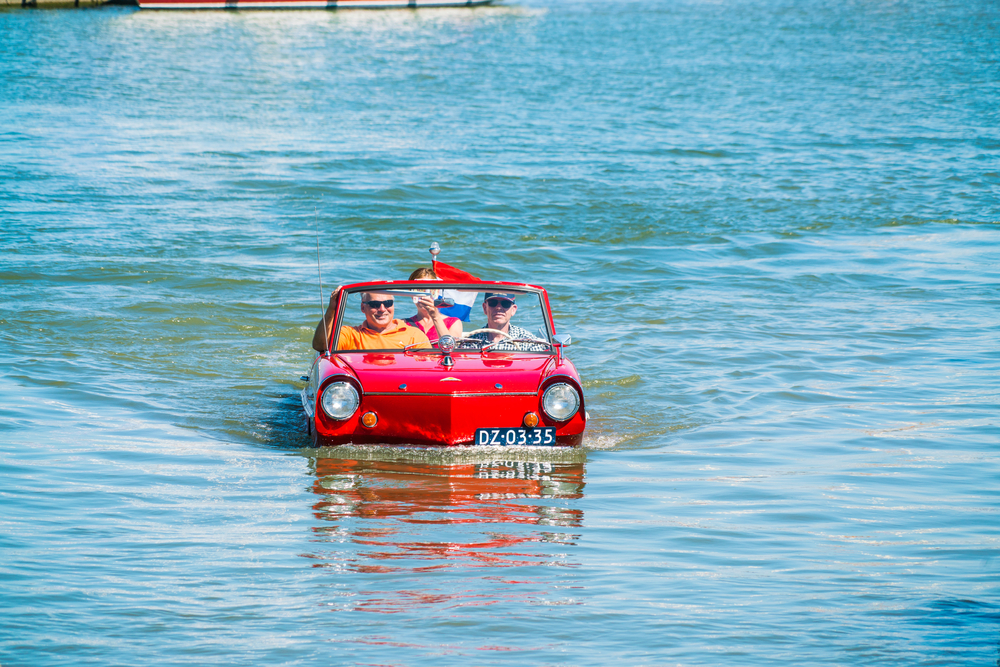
left=303, top=457, right=585, bottom=613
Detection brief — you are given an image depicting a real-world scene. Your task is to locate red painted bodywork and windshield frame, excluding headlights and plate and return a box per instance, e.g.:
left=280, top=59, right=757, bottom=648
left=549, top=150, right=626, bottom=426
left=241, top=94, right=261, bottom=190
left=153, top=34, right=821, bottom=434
left=302, top=281, right=586, bottom=446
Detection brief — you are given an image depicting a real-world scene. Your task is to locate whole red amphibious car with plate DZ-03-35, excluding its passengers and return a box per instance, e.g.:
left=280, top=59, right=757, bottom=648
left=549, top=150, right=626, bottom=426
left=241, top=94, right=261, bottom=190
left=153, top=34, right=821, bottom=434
left=302, top=281, right=587, bottom=447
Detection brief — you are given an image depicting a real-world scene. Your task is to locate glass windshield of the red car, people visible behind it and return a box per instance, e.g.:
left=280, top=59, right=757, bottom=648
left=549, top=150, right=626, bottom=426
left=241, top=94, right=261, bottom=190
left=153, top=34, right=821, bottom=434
left=334, top=286, right=552, bottom=354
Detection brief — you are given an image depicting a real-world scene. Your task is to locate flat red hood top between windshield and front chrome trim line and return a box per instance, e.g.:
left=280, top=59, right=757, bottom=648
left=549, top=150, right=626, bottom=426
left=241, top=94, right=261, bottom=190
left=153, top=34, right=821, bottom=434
left=337, top=352, right=555, bottom=394
